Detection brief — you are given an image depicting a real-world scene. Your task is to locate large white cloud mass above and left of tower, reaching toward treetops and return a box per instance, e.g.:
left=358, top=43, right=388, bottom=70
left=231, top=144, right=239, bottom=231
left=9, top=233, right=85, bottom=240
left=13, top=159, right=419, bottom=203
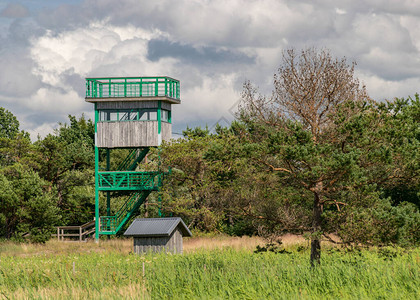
left=21, top=23, right=174, bottom=139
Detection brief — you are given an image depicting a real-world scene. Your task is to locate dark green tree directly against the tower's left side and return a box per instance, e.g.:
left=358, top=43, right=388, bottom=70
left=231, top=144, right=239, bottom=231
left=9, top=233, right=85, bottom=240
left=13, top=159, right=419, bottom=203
left=35, top=116, right=95, bottom=225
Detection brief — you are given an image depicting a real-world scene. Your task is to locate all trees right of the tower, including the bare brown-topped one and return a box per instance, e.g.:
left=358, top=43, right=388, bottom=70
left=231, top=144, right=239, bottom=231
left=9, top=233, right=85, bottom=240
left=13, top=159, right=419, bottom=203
left=158, top=49, right=420, bottom=261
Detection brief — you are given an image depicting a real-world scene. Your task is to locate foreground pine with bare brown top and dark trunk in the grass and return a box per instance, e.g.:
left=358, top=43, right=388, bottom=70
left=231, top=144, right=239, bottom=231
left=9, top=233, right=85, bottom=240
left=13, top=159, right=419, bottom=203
left=238, top=48, right=418, bottom=264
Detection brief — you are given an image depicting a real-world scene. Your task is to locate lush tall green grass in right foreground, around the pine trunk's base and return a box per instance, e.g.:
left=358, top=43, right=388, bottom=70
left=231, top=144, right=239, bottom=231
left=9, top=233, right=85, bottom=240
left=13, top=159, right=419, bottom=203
left=146, top=250, right=420, bottom=299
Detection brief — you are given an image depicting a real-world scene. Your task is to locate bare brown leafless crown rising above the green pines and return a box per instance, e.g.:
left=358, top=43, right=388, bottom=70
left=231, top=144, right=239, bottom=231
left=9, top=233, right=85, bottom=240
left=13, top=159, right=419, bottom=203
left=273, top=48, right=368, bottom=141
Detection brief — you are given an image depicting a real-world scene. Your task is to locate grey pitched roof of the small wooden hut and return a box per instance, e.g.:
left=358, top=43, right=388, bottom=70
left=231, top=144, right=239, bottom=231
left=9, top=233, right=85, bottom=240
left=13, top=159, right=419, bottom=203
left=124, top=217, right=192, bottom=237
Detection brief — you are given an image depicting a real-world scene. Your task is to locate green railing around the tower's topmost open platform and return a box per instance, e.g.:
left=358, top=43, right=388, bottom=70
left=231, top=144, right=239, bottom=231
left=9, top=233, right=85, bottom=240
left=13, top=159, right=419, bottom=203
left=86, top=77, right=180, bottom=100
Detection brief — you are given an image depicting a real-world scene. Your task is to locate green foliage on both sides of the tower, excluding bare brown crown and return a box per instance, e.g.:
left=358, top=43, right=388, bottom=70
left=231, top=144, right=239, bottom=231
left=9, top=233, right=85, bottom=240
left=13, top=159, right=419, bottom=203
left=0, top=95, right=420, bottom=246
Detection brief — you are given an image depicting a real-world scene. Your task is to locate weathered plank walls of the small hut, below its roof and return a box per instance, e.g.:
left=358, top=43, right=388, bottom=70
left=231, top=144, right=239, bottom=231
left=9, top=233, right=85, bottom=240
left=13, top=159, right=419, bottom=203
left=134, top=228, right=182, bottom=254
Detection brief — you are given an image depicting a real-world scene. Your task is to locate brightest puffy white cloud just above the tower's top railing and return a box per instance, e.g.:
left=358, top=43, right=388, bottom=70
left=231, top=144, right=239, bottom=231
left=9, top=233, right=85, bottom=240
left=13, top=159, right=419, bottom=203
left=31, top=22, right=160, bottom=81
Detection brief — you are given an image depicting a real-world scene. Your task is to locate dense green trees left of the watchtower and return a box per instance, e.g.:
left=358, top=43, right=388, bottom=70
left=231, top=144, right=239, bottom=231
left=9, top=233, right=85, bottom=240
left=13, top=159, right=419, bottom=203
left=0, top=113, right=94, bottom=242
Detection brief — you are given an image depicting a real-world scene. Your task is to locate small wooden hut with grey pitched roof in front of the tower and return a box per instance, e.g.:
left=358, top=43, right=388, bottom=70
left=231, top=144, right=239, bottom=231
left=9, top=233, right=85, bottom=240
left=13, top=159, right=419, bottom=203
left=124, top=217, right=192, bottom=254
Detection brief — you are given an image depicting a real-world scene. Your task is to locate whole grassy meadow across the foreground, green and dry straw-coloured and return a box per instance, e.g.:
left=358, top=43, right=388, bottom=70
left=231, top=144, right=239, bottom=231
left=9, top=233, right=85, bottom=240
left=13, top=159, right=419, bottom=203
left=0, top=237, right=420, bottom=299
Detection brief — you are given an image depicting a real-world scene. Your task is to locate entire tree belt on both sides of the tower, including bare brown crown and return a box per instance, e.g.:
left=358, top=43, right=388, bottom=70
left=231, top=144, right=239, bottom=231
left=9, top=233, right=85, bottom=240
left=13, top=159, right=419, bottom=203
left=0, top=49, right=420, bottom=248
